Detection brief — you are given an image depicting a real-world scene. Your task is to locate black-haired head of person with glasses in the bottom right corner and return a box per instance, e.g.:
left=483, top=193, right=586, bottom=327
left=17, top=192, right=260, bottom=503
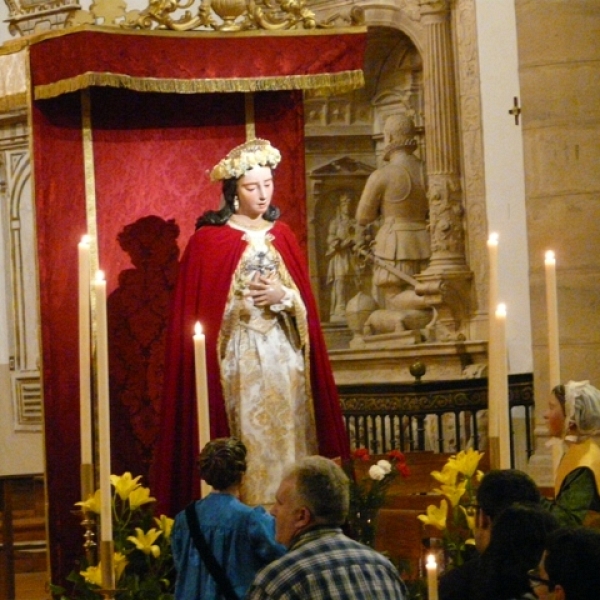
left=544, top=527, right=600, bottom=600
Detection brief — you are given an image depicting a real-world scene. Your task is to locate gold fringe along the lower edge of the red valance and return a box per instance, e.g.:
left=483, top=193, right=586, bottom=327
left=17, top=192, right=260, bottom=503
left=35, top=70, right=365, bottom=100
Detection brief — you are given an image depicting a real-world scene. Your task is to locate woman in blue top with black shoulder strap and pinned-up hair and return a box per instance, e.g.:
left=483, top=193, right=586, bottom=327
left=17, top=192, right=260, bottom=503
left=171, top=438, right=285, bottom=600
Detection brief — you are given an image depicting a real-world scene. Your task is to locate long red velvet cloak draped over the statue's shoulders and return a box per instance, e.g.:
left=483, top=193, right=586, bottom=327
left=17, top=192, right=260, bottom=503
left=152, top=222, right=349, bottom=516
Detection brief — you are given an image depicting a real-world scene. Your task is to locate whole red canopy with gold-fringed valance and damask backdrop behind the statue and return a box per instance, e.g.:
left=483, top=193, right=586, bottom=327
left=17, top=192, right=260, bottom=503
left=30, top=24, right=365, bottom=583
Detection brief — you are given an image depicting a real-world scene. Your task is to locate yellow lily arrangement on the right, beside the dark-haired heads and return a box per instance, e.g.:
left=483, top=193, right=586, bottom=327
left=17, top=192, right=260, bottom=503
left=418, top=448, right=483, bottom=569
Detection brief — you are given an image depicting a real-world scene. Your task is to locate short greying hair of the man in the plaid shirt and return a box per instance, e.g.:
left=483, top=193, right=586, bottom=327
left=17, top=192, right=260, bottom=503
left=290, top=456, right=350, bottom=526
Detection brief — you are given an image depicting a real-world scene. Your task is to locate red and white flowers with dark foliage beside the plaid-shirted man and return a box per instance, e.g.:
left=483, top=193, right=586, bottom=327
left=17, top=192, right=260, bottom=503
left=348, top=448, right=410, bottom=546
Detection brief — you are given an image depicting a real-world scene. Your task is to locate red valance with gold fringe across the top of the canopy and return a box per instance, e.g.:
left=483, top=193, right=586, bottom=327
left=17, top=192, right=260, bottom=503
left=30, top=28, right=366, bottom=99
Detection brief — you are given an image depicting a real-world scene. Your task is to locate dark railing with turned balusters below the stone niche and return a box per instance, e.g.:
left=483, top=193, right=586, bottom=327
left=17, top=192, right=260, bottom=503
left=338, top=373, right=534, bottom=466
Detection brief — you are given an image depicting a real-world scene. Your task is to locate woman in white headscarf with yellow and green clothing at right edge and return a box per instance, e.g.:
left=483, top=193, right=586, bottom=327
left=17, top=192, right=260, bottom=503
left=544, top=381, right=600, bottom=525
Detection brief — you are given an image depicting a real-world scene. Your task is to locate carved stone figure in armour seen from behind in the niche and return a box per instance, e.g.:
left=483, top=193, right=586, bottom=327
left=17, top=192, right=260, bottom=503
left=354, top=114, right=433, bottom=345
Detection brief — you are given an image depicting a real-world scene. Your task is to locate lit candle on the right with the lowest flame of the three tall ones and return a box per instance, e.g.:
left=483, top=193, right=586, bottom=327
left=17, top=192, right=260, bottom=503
left=494, top=304, right=511, bottom=469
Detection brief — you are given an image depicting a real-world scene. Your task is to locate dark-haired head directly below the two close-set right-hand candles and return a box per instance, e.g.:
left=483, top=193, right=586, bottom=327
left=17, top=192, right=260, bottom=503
left=477, top=469, right=542, bottom=520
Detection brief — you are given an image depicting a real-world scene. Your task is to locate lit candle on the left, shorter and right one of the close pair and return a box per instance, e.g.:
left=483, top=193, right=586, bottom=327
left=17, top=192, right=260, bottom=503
left=94, top=271, right=113, bottom=542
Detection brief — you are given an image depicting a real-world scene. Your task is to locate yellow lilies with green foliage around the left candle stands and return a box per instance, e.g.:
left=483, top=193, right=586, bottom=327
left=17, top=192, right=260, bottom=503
left=51, top=472, right=175, bottom=600
